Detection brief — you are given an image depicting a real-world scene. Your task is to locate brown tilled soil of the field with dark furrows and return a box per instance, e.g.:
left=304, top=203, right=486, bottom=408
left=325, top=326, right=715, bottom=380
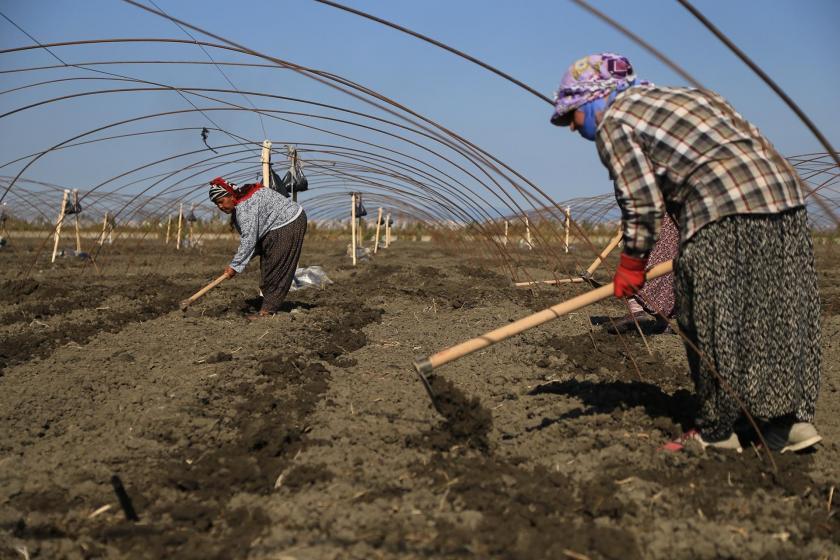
left=0, top=240, right=840, bottom=559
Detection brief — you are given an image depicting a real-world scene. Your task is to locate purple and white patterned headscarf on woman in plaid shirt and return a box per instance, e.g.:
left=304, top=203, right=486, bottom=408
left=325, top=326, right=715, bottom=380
left=551, top=53, right=648, bottom=125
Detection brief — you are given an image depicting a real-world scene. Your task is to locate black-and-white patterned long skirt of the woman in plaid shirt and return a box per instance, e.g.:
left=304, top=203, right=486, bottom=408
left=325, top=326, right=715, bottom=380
left=675, top=208, right=821, bottom=441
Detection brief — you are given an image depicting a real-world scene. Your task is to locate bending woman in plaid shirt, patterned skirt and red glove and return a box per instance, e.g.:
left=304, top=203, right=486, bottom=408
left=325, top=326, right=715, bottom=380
left=551, top=53, right=821, bottom=452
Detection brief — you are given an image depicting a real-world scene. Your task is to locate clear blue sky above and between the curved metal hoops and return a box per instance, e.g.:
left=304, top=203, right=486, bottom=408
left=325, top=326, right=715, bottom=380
left=0, top=0, right=840, bottom=219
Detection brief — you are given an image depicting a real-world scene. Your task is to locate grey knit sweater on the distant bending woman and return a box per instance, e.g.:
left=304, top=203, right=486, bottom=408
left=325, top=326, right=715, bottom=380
left=230, top=187, right=303, bottom=272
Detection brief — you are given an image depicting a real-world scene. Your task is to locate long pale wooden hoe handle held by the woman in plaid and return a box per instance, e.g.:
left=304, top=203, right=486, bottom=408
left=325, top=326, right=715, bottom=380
left=414, top=261, right=673, bottom=376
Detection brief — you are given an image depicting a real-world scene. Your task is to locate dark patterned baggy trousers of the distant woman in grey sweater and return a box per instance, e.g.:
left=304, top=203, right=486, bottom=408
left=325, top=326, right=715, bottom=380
left=257, top=211, right=306, bottom=313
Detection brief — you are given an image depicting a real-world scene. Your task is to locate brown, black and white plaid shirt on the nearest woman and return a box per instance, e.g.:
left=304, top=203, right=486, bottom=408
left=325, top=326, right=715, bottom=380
left=595, top=86, right=804, bottom=256
